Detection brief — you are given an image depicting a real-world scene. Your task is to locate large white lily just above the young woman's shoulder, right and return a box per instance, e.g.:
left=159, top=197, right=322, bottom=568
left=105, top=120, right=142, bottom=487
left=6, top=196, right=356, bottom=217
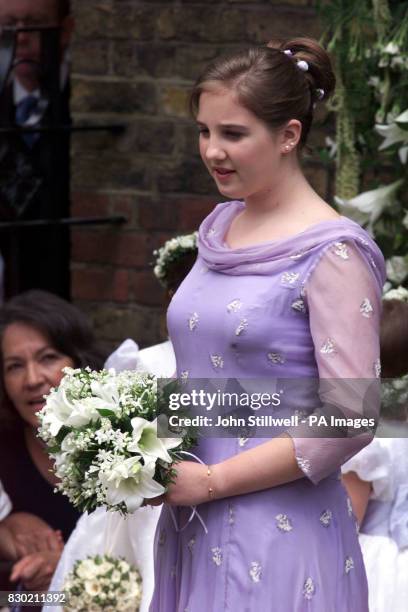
left=335, top=179, right=403, bottom=233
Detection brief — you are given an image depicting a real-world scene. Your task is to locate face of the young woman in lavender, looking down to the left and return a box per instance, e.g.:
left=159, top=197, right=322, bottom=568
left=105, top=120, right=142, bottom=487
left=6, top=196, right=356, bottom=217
left=197, top=87, right=283, bottom=199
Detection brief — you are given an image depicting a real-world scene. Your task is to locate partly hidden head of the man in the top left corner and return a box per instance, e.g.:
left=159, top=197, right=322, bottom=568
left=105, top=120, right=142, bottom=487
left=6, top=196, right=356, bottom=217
left=0, top=0, right=59, bottom=86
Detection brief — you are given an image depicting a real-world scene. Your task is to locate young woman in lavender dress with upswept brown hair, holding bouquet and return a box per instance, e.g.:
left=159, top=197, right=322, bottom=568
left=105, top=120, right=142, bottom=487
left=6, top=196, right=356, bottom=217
left=150, top=39, right=384, bottom=612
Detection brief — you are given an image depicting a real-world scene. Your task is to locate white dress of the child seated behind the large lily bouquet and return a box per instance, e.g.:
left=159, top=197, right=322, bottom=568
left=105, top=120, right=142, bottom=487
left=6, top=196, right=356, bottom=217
left=43, top=339, right=176, bottom=612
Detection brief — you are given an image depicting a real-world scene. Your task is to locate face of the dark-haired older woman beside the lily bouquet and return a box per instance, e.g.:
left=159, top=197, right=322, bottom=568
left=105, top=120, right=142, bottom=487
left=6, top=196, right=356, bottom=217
left=1, top=323, right=74, bottom=427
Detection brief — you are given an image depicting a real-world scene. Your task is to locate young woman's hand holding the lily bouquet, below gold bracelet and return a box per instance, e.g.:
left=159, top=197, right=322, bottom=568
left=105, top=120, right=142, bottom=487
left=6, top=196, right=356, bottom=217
left=146, top=461, right=214, bottom=506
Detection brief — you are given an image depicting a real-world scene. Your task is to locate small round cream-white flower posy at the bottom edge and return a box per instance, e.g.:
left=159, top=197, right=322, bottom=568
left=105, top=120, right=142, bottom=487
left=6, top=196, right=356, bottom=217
left=62, top=555, right=142, bottom=612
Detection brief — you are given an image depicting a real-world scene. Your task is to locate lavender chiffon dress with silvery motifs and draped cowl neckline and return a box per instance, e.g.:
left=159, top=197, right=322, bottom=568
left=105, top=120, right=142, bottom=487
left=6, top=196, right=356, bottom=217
left=150, top=202, right=384, bottom=612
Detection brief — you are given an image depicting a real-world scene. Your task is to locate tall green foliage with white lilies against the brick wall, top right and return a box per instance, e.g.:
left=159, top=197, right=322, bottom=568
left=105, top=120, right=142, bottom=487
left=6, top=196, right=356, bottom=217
left=317, top=0, right=408, bottom=289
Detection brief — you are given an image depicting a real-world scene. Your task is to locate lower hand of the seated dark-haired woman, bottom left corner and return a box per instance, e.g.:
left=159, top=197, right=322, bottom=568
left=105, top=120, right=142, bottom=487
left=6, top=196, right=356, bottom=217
left=10, top=550, right=61, bottom=591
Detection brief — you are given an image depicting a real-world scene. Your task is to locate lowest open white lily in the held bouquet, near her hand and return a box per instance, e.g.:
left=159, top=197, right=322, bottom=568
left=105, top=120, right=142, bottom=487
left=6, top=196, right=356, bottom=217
left=99, top=456, right=166, bottom=512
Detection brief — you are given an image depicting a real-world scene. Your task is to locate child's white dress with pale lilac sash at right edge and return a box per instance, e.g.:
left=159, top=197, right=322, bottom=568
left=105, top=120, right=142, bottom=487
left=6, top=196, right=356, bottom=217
left=342, top=437, right=408, bottom=612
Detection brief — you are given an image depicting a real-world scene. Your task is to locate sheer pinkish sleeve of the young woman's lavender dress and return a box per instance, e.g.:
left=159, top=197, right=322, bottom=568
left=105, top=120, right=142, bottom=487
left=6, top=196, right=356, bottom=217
left=288, top=242, right=381, bottom=484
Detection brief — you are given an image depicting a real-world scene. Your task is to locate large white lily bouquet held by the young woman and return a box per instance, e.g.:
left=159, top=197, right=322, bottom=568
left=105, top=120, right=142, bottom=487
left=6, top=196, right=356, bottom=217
left=38, top=368, right=195, bottom=515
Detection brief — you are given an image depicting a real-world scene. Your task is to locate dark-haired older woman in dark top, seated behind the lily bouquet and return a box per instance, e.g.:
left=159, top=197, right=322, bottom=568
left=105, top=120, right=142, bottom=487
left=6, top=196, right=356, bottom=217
left=0, top=291, right=103, bottom=590
